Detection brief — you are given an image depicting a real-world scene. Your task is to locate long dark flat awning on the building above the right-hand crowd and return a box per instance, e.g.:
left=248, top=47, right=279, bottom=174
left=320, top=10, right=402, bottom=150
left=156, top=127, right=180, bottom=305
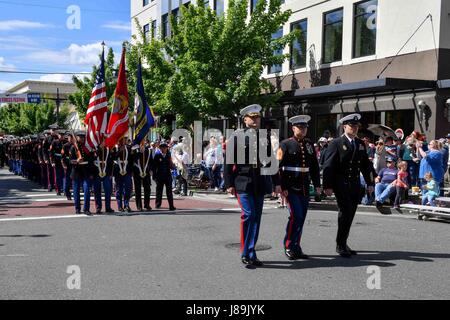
left=285, top=78, right=438, bottom=99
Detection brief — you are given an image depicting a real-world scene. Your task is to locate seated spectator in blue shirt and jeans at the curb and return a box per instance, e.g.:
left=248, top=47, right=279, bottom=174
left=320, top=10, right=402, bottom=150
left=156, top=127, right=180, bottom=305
left=375, top=156, right=398, bottom=208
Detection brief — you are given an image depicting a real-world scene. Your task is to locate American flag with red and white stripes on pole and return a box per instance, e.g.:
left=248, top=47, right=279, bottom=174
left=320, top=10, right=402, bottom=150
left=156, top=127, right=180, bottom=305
left=84, top=44, right=108, bottom=151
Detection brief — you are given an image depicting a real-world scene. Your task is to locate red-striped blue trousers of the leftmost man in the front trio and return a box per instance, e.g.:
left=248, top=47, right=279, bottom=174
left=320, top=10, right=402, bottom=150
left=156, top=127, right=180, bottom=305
left=236, top=193, right=264, bottom=260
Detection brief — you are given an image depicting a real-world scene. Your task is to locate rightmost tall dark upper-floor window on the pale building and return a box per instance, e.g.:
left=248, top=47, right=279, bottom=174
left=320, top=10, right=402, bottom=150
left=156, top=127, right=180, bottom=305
left=353, top=0, right=378, bottom=58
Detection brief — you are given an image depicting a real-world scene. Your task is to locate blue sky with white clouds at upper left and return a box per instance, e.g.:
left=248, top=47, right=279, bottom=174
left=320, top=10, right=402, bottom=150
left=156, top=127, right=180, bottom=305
left=0, top=0, right=131, bottom=92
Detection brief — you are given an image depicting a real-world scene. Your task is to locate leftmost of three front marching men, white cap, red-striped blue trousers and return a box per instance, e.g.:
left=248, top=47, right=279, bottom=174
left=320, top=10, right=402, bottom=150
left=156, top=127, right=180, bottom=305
left=224, top=104, right=281, bottom=266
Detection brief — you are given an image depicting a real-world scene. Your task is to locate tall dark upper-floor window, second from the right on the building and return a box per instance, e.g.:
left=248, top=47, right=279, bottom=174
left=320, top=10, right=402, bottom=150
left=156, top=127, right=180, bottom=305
left=322, top=8, right=344, bottom=63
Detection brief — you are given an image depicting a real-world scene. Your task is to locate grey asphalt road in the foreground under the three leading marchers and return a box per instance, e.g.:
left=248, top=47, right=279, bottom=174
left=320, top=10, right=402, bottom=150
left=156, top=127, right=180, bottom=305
left=0, top=209, right=450, bottom=300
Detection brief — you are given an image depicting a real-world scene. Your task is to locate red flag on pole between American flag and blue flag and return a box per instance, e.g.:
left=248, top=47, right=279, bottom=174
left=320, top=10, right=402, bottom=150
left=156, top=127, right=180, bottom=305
left=105, top=48, right=128, bottom=149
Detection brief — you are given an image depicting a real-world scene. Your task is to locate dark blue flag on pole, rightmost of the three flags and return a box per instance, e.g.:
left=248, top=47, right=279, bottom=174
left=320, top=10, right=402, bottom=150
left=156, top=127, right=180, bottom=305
left=133, top=60, right=155, bottom=145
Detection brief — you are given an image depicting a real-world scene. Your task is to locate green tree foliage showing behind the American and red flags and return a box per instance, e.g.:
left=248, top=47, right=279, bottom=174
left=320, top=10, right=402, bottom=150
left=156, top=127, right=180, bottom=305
left=69, top=48, right=117, bottom=119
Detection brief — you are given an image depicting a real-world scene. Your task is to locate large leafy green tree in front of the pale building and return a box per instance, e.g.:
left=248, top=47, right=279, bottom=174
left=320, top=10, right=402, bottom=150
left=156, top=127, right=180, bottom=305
left=128, top=0, right=298, bottom=127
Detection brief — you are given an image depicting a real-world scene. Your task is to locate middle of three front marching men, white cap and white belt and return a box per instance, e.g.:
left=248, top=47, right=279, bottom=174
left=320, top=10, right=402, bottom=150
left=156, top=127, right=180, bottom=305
left=277, top=115, right=322, bottom=260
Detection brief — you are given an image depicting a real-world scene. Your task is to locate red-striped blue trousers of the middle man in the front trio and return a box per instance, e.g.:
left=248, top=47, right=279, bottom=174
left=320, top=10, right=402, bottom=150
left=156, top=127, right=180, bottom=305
left=284, top=192, right=309, bottom=251
